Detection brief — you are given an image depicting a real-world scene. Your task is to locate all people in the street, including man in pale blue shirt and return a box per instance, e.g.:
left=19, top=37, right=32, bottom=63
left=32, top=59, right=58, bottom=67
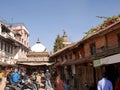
left=0, top=68, right=120, bottom=90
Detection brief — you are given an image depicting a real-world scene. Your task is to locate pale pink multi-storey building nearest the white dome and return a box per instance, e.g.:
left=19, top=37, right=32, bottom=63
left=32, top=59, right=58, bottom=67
left=11, top=24, right=30, bottom=60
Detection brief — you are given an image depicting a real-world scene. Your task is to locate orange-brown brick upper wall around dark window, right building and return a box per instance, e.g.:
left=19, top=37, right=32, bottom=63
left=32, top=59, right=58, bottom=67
left=84, top=29, right=120, bottom=57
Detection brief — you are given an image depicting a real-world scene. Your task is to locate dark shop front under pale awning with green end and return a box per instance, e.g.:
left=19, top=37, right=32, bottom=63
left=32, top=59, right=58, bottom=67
left=93, top=54, right=120, bottom=87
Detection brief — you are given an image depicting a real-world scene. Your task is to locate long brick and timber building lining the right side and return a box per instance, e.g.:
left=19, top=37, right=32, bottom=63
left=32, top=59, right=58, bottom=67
left=50, top=16, right=120, bottom=90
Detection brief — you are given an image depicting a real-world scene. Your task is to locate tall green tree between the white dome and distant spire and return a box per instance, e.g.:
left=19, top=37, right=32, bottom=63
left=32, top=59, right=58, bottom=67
left=54, top=35, right=64, bottom=52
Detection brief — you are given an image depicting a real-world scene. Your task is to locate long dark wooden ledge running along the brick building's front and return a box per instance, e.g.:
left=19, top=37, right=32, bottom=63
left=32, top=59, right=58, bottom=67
left=60, top=47, right=120, bottom=65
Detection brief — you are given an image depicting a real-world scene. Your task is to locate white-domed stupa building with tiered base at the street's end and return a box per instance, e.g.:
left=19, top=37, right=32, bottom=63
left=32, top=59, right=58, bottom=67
left=17, top=39, right=52, bottom=72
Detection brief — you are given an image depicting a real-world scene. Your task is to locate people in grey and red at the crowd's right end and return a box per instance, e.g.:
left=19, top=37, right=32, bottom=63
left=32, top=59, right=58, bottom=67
left=45, top=70, right=70, bottom=90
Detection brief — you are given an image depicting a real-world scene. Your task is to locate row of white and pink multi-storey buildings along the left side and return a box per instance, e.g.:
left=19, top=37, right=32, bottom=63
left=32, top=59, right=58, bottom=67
left=0, top=21, right=29, bottom=64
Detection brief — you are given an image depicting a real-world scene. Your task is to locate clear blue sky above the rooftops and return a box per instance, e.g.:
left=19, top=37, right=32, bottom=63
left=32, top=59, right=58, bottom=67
left=0, top=0, right=120, bottom=51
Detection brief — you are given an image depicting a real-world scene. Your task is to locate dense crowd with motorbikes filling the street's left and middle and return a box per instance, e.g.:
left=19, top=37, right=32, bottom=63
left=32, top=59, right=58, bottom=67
left=0, top=68, right=69, bottom=90
